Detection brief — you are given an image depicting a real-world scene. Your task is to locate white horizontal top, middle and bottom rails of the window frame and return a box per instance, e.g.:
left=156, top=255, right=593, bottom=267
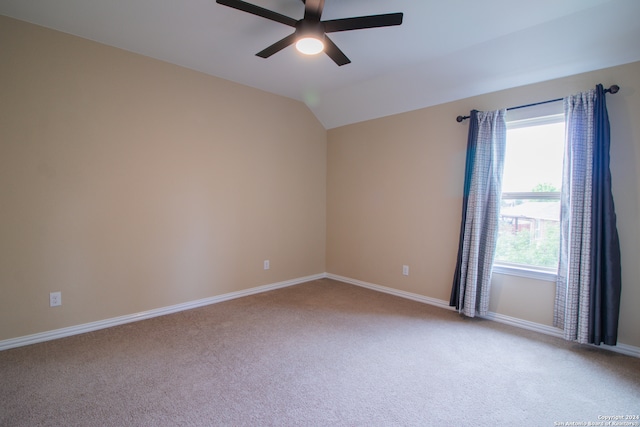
left=492, top=110, right=564, bottom=282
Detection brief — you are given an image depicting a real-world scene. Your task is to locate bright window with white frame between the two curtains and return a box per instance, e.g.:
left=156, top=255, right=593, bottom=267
left=494, top=108, right=564, bottom=279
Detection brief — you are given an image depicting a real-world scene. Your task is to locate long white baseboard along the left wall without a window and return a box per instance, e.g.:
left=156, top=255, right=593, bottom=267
left=0, top=273, right=326, bottom=351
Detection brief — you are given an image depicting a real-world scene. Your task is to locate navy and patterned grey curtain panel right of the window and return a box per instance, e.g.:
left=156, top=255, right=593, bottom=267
left=554, top=85, right=621, bottom=345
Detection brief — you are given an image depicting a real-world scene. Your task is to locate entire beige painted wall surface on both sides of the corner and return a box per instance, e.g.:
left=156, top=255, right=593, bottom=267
left=0, top=17, right=640, bottom=352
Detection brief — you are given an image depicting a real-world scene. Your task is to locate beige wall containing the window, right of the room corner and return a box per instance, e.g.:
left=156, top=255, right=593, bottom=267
left=327, top=63, right=640, bottom=346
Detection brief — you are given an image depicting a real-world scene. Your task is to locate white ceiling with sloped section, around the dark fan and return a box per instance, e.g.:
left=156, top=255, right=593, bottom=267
left=0, top=0, right=640, bottom=129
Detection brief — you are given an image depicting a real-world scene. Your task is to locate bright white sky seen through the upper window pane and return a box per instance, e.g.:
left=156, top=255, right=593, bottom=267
left=502, top=122, right=564, bottom=193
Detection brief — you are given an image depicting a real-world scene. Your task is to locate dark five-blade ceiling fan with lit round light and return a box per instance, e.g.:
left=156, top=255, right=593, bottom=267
left=216, top=0, right=402, bottom=66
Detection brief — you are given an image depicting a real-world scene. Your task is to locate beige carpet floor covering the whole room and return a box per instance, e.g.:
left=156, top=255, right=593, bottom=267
left=0, top=279, right=640, bottom=426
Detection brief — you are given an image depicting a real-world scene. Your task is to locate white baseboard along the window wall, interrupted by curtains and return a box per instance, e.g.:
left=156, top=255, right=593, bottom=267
left=326, top=273, right=640, bottom=358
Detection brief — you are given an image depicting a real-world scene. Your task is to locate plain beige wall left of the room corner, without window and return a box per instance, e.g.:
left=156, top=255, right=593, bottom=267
left=0, top=16, right=326, bottom=340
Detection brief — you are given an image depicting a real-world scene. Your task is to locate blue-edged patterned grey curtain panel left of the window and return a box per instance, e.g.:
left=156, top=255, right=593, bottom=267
left=449, top=109, right=507, bottom=317
